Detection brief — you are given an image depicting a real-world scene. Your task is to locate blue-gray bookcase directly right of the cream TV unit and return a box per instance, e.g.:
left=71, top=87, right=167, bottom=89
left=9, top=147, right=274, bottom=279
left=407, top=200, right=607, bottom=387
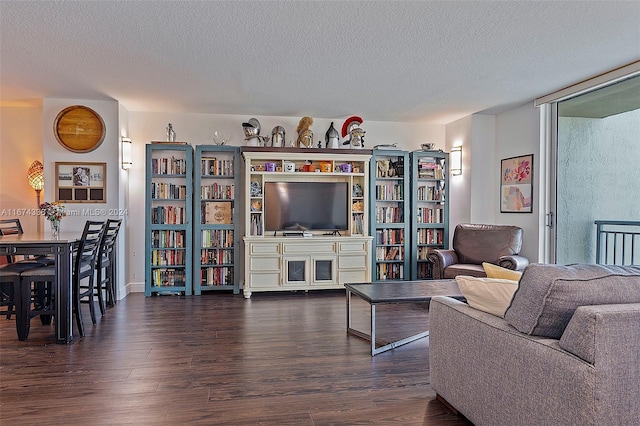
left=369, top=149, right=411, bottom=281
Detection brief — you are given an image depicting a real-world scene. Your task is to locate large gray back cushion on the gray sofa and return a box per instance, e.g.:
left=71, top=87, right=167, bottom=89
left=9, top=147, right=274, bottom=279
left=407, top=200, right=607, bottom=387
left=504, top=264, right=640, bottom=339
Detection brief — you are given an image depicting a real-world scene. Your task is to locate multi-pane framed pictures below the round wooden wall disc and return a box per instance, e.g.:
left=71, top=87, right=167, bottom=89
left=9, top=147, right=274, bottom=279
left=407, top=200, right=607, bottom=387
left=56, top=162, right=107, bottom=203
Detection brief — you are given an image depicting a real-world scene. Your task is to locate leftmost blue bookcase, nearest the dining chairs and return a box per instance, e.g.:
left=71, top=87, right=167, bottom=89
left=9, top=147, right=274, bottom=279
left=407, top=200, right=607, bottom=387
left=145, top=143, right=193, bottom=296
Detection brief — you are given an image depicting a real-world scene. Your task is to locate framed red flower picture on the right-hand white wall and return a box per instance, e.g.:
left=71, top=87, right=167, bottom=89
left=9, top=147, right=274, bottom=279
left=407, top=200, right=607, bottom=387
left=500, top=154, right=533, bottom=213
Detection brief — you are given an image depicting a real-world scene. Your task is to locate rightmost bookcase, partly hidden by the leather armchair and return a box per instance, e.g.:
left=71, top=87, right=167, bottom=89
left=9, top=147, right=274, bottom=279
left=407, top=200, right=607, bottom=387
left=410, top=151, right=449, bottom=280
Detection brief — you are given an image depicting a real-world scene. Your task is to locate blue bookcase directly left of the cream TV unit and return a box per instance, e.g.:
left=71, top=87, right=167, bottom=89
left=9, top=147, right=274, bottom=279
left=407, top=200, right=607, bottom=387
left=193, top=145, right=241, bottom=295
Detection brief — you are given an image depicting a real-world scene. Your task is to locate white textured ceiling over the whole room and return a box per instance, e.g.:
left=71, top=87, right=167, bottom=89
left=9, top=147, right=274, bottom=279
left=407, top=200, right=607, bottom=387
left=0, top=0, right=640, bottom=123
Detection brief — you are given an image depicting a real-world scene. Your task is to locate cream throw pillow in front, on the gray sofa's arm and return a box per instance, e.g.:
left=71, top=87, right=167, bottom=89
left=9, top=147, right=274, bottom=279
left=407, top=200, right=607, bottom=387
left=456, top=275, right=518, bottom=318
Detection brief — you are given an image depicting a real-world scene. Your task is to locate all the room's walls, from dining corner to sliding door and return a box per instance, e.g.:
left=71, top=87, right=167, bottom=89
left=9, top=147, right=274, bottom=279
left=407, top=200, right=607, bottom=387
left=0, top=99, right=540, bottom=297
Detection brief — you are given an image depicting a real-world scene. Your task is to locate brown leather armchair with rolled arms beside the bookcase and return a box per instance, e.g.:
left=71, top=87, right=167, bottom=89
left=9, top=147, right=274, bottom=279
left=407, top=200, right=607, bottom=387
left=429, top=223, right=529, bottom=280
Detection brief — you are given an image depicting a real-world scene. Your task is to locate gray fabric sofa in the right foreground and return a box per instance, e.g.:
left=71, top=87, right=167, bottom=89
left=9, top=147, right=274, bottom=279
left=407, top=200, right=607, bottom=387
left=429, top=264, right=640, bottom=426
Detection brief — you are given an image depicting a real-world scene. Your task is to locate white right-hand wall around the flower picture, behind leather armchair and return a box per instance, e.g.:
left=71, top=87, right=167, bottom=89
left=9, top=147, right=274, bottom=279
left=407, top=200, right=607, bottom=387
left=446, top=103, right=540, bottom=262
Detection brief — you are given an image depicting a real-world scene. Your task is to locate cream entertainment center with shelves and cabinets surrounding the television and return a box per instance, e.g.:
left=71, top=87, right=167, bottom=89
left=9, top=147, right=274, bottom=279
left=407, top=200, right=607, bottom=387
left=242, top=147, right=372, bottom=298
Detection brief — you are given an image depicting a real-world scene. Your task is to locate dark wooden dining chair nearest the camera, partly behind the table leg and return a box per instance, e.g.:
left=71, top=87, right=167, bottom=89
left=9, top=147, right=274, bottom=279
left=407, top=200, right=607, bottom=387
left=20, top=220, right=106, bottom=338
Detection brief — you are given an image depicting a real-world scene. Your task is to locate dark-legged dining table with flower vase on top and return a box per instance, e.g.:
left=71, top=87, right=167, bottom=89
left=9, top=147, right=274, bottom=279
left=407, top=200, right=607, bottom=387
left=0, top=230, right=82, bottom=344
